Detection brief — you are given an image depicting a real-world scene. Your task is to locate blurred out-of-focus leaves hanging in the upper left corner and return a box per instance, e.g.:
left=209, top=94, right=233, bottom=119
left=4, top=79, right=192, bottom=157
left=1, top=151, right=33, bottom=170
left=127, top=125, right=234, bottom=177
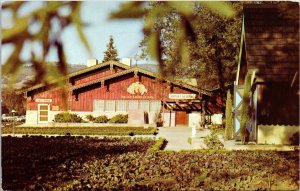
left=2, top=1, right=90, bottom=90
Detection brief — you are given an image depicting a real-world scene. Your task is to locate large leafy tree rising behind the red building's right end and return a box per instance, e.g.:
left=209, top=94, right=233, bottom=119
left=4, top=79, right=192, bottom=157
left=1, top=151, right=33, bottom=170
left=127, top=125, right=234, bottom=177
left=112, top=2, right=242, bottom=90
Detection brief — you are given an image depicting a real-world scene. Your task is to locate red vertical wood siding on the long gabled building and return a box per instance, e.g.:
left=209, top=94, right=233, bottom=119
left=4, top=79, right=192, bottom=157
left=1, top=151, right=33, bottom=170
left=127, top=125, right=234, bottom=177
left=27, top=73, right=198, bottom=111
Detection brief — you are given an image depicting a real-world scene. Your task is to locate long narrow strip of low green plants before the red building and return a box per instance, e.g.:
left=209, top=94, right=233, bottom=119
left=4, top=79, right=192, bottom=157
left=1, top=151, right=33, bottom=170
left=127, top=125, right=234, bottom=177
left=2, top=126, right=157, bottom=136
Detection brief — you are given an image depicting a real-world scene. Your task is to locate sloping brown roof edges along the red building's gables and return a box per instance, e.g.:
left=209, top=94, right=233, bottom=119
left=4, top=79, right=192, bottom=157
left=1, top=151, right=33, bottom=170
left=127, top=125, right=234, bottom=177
left=23, top=61, right=211, bottom=96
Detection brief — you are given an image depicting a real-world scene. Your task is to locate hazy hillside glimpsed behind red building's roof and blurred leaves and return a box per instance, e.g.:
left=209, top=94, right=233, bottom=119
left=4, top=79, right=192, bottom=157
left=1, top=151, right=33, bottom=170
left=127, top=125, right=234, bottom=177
left=2, top=64, right=158, bottom=89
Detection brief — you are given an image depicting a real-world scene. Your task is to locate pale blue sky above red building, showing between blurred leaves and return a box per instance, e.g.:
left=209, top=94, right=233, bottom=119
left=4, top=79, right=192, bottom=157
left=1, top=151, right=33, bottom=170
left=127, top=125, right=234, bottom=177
left=1, top=1, right=149, bottom=64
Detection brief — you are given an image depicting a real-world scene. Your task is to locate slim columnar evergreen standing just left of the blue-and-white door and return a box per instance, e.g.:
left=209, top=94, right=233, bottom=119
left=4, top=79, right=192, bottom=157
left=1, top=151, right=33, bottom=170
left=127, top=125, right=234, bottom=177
left=225, top=90, right=233, bottom=140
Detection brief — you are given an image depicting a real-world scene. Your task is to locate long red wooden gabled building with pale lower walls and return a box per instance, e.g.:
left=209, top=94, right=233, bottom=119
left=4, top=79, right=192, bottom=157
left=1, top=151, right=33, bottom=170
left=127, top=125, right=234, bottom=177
left=25, top=60, right=211, bottom=126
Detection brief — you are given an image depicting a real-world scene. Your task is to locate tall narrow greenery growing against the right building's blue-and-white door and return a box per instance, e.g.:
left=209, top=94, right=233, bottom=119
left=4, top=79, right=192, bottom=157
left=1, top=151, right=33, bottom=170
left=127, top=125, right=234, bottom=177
left=240, top=72, right=251, bottom=143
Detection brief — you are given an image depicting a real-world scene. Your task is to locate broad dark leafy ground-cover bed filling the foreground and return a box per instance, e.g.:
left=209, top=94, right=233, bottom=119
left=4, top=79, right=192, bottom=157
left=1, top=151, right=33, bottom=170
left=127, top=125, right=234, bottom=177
left=2, top=136, right=299, bottom=190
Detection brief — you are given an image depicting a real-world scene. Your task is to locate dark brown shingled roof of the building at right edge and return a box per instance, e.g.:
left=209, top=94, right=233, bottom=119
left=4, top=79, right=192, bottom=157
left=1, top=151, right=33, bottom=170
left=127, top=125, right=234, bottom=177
left=238, top=3, right=299, bottom=82
